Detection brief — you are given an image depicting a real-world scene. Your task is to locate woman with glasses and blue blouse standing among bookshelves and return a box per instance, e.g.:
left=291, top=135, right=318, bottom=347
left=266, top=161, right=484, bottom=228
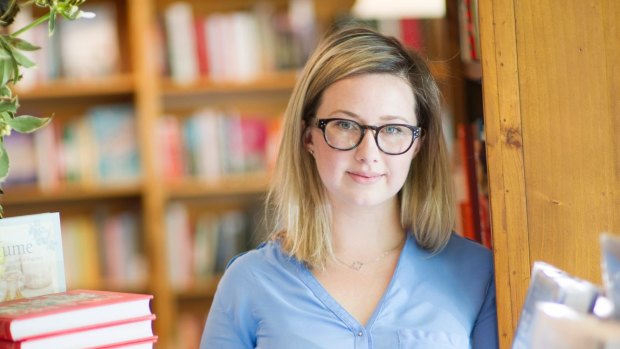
left=201, top=27, right=497, bottom=349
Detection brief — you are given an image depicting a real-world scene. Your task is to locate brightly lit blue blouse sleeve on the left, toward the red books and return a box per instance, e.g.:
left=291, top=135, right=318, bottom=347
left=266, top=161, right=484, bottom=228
left=200, top=254, right=256, bottom=349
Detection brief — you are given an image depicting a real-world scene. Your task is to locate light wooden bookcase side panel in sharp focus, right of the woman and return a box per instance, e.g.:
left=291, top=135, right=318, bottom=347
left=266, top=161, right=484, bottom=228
left=479, top=0, right=620, bottom=348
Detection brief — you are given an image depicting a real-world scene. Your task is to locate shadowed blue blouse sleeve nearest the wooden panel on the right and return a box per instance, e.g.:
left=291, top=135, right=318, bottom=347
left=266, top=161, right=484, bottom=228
left=472, top=260, right=499, bottom=349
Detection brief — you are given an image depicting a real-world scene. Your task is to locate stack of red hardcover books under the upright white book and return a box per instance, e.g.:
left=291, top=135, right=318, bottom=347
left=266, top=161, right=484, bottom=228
left=0, top=290, right=157, bottom=349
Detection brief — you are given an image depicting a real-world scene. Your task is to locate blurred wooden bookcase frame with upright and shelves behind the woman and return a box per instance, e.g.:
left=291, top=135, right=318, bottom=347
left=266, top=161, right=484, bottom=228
left=0, top=0, right=464, bottom=349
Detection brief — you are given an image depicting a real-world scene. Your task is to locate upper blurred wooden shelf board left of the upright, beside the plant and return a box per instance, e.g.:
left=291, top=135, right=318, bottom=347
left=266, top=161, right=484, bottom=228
left=15, top=74, right=135, bottom=102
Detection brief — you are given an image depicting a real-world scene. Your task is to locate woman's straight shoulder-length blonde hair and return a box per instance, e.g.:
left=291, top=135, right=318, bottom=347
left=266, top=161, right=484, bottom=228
left=267, top=26, right=455, bottom=267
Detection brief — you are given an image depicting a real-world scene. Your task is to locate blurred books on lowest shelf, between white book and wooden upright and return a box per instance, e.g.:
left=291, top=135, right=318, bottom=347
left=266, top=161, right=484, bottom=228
left=61, top=211, right=148, bottom=289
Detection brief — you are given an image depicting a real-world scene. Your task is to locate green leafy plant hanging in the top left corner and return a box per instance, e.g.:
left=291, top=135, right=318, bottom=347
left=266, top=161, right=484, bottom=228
left=0, top=0, right=94, bottom=218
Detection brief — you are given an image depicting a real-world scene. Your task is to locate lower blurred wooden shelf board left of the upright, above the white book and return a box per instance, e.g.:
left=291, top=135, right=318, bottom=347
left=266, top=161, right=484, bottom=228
left=0, top=184, right=142, bottom=206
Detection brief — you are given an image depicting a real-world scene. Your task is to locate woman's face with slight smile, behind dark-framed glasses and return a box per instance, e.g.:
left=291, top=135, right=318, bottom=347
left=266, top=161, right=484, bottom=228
left=305, top=74, right=420, bottom=207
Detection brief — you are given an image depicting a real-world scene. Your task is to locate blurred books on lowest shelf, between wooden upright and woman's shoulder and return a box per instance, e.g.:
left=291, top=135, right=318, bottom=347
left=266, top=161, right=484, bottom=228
left=165, top=202, right=262, bottom=291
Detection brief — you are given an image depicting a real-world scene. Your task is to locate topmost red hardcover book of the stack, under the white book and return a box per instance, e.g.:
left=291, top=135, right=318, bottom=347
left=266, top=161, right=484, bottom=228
left=0, top=290, right=153, bottom=341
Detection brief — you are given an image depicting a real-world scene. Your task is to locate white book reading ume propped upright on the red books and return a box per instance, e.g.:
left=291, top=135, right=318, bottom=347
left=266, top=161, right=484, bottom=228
left=0, top=212, right=66, bottom=300
